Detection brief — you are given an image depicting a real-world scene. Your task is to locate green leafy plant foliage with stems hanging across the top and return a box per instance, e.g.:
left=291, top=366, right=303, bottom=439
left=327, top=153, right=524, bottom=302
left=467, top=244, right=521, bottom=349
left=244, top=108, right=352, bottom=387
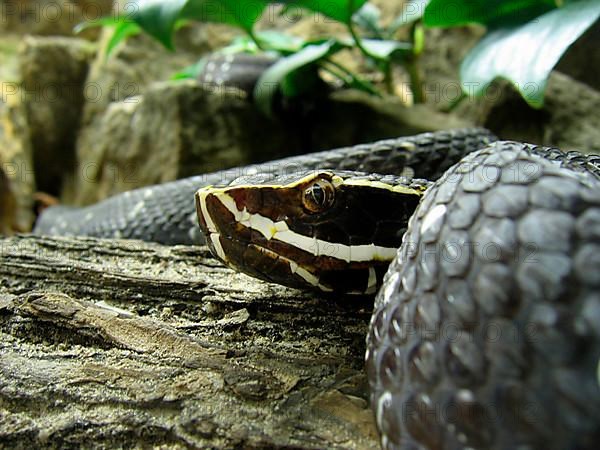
left=81, top=0, right=600, bottom=114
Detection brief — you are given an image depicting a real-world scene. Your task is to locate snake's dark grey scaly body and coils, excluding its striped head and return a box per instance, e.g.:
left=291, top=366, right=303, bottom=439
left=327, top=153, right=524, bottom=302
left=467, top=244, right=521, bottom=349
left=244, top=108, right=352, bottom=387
left=35, top=129, right=600, bottom=449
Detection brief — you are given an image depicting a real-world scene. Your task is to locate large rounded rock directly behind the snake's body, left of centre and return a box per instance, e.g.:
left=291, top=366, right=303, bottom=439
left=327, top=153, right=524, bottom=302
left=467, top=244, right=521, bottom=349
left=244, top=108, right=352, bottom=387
left=65, top=80, right=290, bottom=204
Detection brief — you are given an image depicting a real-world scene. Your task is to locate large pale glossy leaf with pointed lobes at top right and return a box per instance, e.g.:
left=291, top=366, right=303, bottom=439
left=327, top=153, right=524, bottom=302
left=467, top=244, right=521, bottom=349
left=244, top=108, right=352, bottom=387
left=460, top=0, right=600, bottom=108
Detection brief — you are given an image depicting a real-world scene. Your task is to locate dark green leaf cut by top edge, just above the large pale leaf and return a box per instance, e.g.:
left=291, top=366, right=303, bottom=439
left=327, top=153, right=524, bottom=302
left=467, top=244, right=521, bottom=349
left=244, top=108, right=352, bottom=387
left=423, top=0, right=562, bottom=27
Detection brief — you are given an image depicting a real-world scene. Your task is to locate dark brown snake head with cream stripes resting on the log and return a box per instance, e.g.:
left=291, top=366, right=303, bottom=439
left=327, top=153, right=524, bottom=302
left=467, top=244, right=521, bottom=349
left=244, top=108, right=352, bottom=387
left=196, top=171, right=428, bottom=294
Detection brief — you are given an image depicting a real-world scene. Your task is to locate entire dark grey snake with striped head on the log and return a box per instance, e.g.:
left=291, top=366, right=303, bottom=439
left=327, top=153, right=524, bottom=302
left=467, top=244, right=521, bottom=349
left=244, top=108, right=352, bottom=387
left=34, top=128, right=600, bottom=449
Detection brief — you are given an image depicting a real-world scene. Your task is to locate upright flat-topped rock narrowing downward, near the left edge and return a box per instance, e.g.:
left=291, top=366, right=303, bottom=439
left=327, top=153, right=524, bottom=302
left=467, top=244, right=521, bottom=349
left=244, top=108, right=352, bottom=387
left=18, top=37, right=94, bottom=194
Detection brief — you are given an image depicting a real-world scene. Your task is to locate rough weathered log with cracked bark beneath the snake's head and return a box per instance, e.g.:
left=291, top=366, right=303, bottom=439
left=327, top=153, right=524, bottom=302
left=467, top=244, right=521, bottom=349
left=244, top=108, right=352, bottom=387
left=0, top=236, right=377, bottom=449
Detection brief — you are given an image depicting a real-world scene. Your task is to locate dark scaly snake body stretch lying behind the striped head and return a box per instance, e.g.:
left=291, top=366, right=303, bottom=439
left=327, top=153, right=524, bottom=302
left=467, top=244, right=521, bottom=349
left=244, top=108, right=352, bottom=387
left=34, top=129, right=495, bottom=244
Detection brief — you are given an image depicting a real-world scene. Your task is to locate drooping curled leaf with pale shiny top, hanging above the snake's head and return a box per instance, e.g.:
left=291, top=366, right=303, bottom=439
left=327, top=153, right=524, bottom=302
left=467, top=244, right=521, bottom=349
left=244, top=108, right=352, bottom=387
left=254, top=39, right=345, bottom=116
